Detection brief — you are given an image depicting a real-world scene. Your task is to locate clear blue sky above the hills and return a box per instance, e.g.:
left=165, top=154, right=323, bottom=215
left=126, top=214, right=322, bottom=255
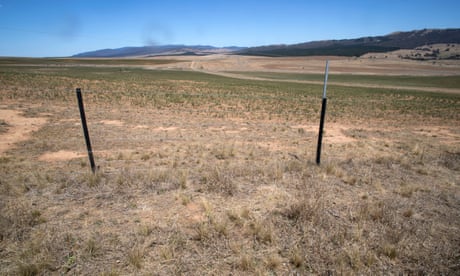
left=0, top=0, right=460, bottom=57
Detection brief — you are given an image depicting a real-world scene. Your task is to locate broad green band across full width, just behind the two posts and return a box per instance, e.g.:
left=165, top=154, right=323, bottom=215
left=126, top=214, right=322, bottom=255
left=0, top=66, right=460, bottom=120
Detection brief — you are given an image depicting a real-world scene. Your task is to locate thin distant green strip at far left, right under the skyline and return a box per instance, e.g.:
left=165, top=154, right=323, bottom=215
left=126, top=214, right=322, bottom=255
left=0, top=57, right=179, bottom=66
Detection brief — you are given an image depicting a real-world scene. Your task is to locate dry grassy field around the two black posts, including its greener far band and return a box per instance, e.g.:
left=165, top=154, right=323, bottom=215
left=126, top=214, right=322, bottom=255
left=0, top=57, right=460, bottom=275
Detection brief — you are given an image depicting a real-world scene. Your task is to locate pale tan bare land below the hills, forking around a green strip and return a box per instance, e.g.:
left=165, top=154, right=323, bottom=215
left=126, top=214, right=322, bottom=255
left=144, top=55, right=460, bottom=94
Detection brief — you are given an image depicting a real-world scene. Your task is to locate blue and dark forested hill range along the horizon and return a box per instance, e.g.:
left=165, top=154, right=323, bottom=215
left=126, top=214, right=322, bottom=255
left=74, top=29, right=460, bottom=57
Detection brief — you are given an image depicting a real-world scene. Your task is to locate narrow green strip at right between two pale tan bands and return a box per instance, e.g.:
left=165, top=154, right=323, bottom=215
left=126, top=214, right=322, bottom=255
left=231, top=72, right=460, bottom=89
